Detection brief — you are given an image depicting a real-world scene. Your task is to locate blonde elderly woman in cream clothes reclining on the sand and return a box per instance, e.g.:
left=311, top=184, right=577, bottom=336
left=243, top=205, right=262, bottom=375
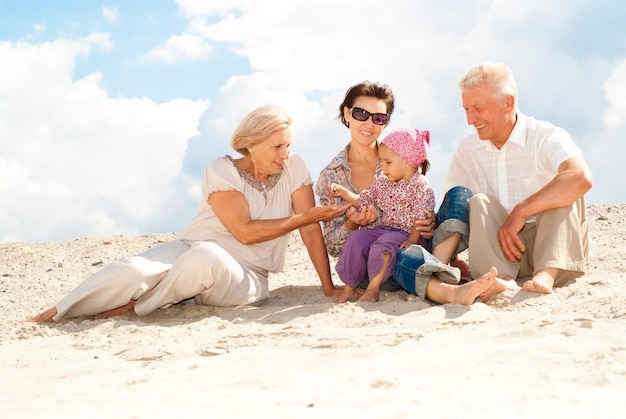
left=29, top=106, right=350, bottom=322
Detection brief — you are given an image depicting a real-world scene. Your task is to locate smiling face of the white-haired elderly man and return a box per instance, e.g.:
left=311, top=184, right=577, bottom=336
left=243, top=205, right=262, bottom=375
left=461, top=86, right=516, bottom=148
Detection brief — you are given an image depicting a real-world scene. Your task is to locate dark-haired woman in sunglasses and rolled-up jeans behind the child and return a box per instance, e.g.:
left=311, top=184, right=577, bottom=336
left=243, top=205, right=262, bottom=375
left=315, top=81, right=497, bottom=305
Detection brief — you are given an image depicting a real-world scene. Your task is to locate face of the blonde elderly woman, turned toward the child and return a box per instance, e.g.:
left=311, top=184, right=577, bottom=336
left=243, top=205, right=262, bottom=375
left=248, top=128, right=292, bottom=181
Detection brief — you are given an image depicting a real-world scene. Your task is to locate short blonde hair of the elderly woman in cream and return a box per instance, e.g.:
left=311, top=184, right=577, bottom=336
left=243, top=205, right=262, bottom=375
left=230, top=105, right=292, bottom=156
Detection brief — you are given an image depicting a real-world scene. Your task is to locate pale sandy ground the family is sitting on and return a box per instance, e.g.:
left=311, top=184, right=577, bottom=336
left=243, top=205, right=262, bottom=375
left=0, top=205, right=626, bottom=418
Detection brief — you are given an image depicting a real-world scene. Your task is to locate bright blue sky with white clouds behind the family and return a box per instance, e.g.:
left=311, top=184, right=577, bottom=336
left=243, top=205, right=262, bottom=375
left=0, top=0, right=626, bottom=242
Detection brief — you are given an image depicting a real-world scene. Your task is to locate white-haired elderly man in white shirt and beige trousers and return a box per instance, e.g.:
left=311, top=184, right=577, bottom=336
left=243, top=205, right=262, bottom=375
left=444, top=62, right=592, bottom=300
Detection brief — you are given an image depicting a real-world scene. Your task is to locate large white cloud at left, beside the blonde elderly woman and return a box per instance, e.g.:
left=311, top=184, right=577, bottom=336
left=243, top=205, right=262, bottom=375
left=0, top=36, right=207, bottom=241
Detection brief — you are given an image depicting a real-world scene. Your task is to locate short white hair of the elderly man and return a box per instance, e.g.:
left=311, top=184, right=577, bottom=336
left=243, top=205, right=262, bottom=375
left=459, top=61, right=517, bottom=112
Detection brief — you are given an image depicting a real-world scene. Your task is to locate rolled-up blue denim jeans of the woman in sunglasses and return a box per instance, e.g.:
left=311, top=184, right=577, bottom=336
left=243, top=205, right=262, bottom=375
left=360, top=186, right=473, bottom=298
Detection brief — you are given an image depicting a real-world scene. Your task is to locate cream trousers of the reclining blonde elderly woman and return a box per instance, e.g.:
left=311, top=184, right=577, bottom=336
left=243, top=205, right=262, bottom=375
left=54, top=240, right=269, bottom=321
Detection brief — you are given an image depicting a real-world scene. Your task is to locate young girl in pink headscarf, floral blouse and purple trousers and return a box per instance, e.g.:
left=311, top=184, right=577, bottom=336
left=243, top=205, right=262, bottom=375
left=331, top=128, right=435, bottom=303
